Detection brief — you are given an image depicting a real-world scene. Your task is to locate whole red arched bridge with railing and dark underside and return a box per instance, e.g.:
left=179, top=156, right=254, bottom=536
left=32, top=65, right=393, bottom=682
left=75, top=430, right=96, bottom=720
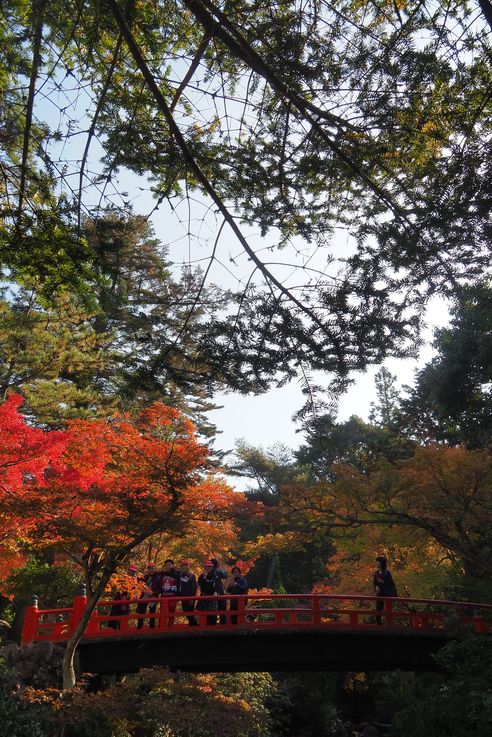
left=22, top=594, right=492, bottom=673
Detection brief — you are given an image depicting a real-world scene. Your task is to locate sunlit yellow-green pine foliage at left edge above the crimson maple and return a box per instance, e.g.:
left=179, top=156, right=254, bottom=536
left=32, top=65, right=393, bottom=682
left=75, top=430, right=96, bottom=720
left=0, top=288, right=108, bottom=427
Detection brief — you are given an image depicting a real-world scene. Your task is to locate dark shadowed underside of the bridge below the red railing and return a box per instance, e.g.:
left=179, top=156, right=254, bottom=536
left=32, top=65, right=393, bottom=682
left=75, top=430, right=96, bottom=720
left=78, top=627, right=448, bottom=673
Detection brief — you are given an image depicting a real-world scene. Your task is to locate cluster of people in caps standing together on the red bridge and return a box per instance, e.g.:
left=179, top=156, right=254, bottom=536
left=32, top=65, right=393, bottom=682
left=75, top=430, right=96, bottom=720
left=108, top=558, right=248, bottom=629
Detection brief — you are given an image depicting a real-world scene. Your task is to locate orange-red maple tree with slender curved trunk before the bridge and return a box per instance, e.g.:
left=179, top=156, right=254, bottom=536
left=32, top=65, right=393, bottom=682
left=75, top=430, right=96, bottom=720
left=0, top=398, right=247, bottom=687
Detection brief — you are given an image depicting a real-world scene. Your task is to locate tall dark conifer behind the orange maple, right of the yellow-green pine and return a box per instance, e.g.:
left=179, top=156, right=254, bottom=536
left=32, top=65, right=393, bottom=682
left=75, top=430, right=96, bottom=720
left=84, top=210, right=232, bottom=420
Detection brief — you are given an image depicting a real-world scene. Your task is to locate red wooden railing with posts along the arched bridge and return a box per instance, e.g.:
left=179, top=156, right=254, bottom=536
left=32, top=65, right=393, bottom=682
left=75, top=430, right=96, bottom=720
left=22, top=594, right=492, bottom=644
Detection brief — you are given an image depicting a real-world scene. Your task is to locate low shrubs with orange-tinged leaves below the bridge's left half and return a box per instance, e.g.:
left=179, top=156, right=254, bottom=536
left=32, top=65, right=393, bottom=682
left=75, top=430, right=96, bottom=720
left=46, top=669, right=286, bottom=737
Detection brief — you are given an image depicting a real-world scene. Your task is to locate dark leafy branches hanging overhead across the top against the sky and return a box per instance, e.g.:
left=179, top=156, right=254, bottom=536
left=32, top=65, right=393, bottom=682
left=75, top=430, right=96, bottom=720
left=0, top=0, right=492, bottom=389
